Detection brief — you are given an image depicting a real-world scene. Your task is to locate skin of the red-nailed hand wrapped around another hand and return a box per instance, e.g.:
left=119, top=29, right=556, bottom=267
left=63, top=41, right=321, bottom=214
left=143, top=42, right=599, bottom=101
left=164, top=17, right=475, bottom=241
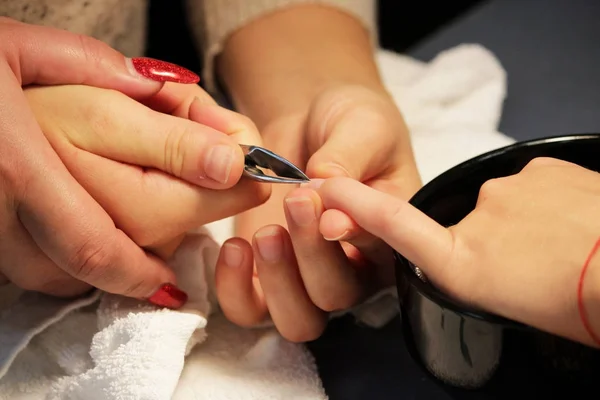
left=0, top=18, right=230, bottom=298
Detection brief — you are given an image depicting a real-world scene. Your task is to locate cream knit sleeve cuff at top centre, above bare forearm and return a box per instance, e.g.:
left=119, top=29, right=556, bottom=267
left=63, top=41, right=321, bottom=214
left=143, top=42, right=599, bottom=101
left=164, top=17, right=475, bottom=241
left=186, top=0, right=377, bottom=93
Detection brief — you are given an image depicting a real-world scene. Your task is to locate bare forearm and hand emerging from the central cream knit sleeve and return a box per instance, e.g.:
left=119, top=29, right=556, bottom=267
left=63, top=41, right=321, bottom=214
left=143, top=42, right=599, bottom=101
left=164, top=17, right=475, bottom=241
left=217, top=5, right=421, bottom=341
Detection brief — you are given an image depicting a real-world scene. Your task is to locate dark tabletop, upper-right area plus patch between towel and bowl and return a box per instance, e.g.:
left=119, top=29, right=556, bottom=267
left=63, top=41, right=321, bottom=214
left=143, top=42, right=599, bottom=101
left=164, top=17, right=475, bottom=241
left=310, top=0, right=600, bottom=400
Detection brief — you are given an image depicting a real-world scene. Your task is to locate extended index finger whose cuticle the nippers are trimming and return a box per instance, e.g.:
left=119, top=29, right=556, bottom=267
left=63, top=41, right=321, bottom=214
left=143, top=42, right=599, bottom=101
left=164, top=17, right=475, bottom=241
left=318, top=178, right=453, bottom=280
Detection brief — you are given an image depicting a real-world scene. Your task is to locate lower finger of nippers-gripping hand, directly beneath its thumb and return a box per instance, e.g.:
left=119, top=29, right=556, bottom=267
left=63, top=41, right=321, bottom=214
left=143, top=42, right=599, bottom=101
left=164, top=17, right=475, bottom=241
left=56, top=150, right=270, bottom=248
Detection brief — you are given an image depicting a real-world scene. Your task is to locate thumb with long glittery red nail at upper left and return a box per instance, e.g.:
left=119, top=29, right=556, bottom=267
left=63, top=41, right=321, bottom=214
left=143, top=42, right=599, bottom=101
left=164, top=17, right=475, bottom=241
left=0, top=18, right=199, bottom=98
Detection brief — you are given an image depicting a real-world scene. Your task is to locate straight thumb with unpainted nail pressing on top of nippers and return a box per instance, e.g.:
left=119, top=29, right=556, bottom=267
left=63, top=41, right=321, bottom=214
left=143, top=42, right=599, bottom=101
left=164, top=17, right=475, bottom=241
left=27, top=86, right=244, bottom=189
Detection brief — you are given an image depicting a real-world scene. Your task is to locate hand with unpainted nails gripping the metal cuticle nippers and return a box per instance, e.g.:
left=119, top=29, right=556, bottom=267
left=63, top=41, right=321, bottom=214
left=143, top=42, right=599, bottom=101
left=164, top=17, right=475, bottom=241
left=21, top=83, right=269, bottom=295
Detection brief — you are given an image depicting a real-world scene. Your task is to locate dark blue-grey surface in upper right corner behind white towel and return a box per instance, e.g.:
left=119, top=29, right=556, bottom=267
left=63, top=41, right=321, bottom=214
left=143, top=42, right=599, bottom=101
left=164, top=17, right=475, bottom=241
left=410, top=0, right=600, bottom=140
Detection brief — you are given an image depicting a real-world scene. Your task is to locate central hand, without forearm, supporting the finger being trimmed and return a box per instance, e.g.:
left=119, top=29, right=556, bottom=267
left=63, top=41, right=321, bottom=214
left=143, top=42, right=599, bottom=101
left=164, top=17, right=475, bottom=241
left=216, top=85, right=420, bottom=341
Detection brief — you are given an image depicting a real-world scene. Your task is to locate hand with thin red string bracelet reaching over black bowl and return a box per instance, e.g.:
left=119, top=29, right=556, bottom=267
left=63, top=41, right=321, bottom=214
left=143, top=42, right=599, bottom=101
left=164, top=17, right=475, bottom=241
left=314, top=158, right=600, bottom=347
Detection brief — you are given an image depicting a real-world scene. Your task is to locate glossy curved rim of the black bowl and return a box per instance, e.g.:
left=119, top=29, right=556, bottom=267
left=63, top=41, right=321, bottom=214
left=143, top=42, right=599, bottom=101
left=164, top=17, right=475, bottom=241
left=395, top=133, right=600, bottom=330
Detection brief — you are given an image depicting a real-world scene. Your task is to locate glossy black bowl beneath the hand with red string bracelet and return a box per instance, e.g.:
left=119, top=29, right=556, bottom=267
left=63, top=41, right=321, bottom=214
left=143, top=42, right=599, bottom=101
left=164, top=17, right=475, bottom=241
left=396, top=134, right=600, bottom=398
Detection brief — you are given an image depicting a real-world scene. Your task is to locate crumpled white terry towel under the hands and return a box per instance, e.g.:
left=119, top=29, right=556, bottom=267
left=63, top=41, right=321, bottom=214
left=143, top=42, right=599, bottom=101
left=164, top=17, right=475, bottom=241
left=0, top=45, right=513, bottom=400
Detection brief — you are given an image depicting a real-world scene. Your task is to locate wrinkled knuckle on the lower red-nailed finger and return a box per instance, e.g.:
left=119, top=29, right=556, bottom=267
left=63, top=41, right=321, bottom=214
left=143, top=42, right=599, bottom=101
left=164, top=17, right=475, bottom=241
left=67, top=237, right=118, bottom=282
